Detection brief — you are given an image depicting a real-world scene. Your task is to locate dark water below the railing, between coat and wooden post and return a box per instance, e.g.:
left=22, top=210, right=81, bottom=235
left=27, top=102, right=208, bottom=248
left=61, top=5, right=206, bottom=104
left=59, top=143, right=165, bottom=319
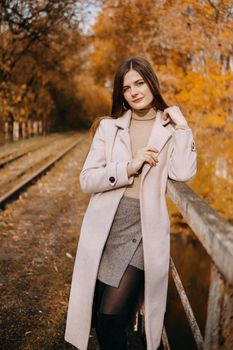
left=164, top=232, right=211, bottom=350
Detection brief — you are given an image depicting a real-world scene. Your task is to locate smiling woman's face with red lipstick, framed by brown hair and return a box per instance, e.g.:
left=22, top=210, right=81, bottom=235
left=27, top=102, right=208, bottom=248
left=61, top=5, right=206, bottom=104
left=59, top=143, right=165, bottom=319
left=123, top=69, right=154, bottom=110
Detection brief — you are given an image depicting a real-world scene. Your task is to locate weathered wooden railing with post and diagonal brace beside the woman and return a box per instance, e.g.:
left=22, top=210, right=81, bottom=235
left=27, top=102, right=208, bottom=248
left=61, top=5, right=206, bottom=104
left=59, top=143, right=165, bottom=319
left=136, top=180, right=233, bottom=350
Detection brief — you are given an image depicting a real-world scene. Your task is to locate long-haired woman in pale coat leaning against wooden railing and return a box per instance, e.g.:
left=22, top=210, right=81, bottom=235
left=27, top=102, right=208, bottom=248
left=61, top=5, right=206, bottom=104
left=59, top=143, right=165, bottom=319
left=65, top=57, right=196, bottom=350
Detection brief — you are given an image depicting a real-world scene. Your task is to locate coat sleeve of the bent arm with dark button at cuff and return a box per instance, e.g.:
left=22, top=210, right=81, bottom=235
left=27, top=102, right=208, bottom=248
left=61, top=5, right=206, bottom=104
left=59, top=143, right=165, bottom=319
left=79, top=119, right=134, bottom=193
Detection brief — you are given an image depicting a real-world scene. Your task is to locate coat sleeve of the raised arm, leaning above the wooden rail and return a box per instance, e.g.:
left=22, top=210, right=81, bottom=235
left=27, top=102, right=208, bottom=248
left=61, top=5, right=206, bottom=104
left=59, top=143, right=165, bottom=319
left=168, top=128, right=197, bottom=182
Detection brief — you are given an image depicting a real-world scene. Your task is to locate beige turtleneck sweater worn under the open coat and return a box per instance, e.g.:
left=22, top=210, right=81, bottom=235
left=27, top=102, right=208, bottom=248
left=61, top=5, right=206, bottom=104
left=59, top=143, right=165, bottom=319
left=124, top=116, right=156, bottom=198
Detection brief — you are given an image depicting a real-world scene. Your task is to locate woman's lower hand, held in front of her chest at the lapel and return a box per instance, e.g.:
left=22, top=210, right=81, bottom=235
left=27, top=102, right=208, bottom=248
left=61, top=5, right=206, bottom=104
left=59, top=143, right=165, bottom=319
left=128, top=146, right=159, bottom=176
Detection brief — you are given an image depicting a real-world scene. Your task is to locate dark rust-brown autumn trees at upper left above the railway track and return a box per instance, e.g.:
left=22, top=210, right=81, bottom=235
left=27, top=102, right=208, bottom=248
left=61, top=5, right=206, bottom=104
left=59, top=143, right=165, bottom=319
left=0, top=0, right=110, bottom=128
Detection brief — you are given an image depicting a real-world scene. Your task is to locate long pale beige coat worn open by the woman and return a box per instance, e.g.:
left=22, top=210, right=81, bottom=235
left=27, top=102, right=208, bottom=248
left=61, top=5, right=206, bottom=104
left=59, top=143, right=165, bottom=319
left=65, top=110, right=196, bottom=350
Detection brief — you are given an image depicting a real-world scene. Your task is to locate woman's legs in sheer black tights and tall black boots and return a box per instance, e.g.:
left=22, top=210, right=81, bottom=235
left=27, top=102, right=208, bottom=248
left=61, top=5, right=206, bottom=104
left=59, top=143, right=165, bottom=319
left=94, top=265, right=144, bottom=350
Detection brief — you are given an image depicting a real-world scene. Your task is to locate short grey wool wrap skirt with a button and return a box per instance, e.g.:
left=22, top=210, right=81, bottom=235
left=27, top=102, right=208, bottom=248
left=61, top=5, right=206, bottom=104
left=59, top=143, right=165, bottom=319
left=97, top=196, right=144, bottom=287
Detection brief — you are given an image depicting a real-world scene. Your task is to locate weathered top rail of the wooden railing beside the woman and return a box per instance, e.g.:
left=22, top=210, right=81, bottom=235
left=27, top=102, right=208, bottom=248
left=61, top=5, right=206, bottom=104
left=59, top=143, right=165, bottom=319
left=167, top=179, right=233, bottom=285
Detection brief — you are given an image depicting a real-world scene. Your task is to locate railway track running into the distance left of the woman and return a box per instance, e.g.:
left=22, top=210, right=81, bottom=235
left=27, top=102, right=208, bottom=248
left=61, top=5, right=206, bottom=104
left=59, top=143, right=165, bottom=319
left=0, top=134, right=82, bottom=209
